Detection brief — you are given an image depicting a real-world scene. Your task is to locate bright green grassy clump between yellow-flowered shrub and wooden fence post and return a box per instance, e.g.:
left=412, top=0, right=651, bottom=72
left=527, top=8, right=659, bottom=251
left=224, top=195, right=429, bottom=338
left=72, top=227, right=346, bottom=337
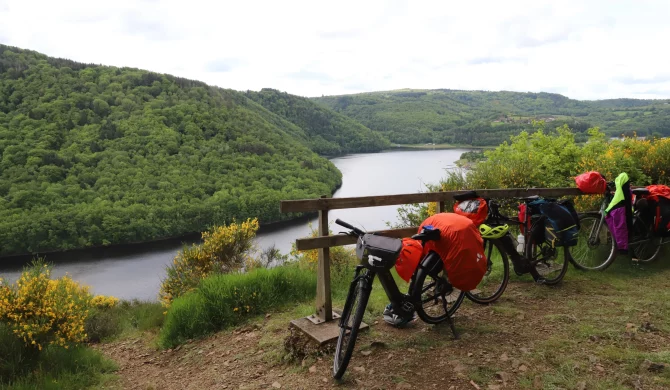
left=160, top=265, right=316, bottom=348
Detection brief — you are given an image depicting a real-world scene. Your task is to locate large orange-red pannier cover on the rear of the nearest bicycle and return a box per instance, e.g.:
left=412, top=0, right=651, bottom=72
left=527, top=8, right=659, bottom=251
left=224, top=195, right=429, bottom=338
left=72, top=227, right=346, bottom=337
left=419, top=213, right=487, bottom=291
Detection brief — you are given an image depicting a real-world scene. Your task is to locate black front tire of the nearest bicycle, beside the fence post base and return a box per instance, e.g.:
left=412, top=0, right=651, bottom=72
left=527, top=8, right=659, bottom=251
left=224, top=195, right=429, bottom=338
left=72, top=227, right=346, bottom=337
left=333, top=277, right=372, bottom=380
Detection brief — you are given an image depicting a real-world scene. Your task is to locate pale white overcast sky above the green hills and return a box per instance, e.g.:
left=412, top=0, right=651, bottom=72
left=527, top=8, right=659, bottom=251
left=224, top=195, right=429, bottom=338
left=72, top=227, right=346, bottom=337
left=0, top=0, right=670, bottom=99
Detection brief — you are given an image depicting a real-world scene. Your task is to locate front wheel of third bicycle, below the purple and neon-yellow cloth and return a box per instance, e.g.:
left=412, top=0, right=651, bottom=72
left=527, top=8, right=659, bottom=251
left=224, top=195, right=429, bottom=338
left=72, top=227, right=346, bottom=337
left=570, top=213, right=617, bottom=271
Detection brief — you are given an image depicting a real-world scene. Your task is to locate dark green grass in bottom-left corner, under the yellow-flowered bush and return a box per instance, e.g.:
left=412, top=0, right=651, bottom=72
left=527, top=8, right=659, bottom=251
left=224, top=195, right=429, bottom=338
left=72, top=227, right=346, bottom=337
left=0, top=323, right=116, bottom=389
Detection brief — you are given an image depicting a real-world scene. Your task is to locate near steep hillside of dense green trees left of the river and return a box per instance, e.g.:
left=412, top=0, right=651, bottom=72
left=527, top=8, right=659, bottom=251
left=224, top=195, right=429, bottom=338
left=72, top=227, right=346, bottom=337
left=0, top=45, right=341, bottom=255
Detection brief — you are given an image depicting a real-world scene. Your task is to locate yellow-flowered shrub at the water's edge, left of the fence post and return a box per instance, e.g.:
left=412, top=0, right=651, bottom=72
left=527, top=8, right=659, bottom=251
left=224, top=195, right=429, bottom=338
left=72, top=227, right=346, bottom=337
left=159, top=219, right=258, bottom=306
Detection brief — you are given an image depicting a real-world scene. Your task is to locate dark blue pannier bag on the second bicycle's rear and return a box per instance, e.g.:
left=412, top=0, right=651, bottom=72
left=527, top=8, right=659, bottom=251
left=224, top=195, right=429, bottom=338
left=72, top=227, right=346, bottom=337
left=528, top=199, right=579, bottom=247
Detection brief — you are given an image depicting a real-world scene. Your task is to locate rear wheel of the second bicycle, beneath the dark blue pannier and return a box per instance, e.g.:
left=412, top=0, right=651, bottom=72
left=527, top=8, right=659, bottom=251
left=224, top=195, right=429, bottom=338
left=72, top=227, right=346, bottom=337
left=525, top=240, right=570, bottom=285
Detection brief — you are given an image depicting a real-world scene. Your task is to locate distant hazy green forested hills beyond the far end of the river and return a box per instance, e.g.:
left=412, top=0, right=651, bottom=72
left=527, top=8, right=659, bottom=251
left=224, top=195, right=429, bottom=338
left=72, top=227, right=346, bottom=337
left=314, top=89, right=670, bottom=146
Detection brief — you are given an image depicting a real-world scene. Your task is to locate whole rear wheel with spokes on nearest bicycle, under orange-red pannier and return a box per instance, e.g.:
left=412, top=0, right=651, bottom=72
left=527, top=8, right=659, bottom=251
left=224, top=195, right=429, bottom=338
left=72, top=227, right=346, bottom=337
left=412, top=269, right=465, bottom=324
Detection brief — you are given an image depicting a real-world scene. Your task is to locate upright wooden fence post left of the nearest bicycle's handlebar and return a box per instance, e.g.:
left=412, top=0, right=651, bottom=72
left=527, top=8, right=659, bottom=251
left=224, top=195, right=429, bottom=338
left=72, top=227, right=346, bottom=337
left=310, top=195, right=333, bottom=324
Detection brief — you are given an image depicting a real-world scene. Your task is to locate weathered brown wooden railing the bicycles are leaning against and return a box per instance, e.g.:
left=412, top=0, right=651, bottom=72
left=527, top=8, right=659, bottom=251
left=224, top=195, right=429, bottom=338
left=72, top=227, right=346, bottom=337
left=280, top=188, right=583, bottom=323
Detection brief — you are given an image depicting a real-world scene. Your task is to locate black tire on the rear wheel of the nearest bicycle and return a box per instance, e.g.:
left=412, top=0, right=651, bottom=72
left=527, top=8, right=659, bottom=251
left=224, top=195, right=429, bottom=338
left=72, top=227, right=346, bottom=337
left=412, top=268, right=465, bottom=324
